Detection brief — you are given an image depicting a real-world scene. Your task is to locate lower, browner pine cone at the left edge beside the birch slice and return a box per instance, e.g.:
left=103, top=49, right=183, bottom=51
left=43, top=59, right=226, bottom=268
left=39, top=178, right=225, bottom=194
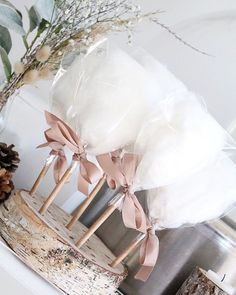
left=0, top=168, right=14, bottom=203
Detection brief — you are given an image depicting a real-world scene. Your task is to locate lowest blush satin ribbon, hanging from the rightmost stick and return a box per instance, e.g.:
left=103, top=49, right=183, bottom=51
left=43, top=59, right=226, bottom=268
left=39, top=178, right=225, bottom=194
left=135, top=227, right=159, bottom=282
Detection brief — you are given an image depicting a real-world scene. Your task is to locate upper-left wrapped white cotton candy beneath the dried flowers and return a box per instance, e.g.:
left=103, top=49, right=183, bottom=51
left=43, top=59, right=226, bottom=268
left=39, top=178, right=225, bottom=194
left=52, top=48, right=162, bottom=155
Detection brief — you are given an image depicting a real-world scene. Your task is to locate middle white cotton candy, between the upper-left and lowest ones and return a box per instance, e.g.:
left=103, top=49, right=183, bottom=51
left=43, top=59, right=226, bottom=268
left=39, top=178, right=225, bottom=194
left=134, top=95, right=227, bottom=189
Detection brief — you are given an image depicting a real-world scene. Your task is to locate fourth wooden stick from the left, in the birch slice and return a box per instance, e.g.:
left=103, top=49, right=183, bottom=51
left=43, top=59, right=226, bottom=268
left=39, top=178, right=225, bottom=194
left=75, top=196, right=122, bottom=248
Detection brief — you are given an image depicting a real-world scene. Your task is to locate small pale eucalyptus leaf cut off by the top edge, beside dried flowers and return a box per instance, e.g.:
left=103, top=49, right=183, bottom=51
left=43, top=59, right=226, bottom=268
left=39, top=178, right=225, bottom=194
left=34, top=0, right=57, bottom=23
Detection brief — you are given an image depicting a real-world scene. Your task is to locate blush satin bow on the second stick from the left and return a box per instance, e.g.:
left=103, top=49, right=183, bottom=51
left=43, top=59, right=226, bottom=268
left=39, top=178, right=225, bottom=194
left=40, top=112, right=102, bottom=195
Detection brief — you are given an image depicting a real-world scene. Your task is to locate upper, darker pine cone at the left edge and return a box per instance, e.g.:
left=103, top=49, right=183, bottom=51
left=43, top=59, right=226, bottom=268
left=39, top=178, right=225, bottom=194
left=0, top=142, right=20, bottom=172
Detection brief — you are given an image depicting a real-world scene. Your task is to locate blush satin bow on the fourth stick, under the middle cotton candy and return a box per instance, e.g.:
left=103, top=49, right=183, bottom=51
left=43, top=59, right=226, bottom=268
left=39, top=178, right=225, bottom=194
left=97, top=153, right=146, bottom=233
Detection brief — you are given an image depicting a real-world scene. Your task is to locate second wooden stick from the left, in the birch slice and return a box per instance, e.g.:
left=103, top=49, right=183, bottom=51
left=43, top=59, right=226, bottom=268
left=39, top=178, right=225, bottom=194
left=39, top=161, right=78, bottom=214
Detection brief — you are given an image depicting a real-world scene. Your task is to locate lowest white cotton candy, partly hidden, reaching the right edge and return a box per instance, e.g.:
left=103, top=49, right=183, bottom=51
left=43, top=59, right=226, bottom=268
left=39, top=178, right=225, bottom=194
left=147, top=156, right=236, bottom=229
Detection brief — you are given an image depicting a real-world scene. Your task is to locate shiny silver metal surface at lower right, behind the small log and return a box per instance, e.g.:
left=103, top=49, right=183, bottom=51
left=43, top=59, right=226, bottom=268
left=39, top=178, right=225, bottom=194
left=122, top=221, right=236, bottom=295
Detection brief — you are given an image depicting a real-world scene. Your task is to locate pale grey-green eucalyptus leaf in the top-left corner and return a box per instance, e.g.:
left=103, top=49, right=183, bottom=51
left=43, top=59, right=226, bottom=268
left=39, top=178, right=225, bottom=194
left=0, top=4, right=25, bottom=35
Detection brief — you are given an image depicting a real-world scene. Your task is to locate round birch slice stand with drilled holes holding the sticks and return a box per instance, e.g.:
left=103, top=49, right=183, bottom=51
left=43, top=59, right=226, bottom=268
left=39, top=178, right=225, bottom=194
left=0, top=191, right=127, bottom=295
